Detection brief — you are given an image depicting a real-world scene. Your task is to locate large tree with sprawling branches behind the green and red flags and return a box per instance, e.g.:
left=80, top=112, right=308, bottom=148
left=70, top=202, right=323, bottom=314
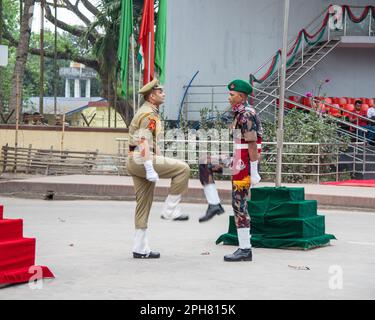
left=4, top=0, right=153, bottom=124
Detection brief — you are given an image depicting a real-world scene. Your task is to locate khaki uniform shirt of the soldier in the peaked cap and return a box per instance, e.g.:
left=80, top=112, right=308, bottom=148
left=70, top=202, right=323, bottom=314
left=129, top=101, right=163, bottom=150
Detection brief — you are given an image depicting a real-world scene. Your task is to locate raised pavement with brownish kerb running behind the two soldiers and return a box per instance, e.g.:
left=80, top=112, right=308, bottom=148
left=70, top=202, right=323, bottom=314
left=0, top=175, right=375, bottom=211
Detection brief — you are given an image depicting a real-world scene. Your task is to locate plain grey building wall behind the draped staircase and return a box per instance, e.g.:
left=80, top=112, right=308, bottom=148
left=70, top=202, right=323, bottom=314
left=164, top=0, right=375, bottom=119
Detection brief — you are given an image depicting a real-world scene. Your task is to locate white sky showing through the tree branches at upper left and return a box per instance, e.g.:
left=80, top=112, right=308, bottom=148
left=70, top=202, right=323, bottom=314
left=32, top=0, right=100, bottom=33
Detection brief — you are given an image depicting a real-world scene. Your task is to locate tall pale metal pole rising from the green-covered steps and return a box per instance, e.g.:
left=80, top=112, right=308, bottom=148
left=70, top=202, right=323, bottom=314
left=276, top=0, right=289, bottom=187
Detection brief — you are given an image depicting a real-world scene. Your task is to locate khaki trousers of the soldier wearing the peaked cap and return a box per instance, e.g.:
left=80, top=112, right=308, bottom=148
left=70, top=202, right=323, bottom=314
left=128, top=152, right=190, bottom=229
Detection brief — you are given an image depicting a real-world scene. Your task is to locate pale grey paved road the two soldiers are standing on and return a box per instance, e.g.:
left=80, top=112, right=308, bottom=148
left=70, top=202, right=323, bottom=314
left=0, top=197, right=375, bottom=300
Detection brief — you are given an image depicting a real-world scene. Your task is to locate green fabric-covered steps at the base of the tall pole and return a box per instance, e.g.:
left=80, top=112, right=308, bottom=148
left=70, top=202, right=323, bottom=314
left=216, top=187, right=335, bottom=249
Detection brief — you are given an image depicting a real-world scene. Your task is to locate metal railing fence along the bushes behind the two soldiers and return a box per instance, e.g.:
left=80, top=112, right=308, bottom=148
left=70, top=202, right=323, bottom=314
left=116, top=138, right=366, bottom=184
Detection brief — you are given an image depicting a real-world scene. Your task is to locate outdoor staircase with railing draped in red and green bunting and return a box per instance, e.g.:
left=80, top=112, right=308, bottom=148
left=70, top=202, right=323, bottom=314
left=251, top=6, right=375, bottom=121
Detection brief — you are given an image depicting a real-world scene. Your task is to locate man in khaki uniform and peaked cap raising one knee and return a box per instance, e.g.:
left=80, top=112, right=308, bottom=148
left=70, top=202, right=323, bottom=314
left=128, top=79, right=190, bottom=258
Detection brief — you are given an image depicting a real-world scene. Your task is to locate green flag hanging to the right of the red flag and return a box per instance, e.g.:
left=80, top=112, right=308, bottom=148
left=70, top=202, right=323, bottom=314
left=155, top=0, right=167, bottom=83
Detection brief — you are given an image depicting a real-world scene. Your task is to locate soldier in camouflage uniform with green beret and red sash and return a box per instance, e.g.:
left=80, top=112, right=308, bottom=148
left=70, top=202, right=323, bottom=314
left=199, top=80, right=261, bottom=261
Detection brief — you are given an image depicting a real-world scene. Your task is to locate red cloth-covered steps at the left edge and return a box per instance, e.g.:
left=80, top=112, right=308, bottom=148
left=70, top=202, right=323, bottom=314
left=0, top=205, right=54, bottom=288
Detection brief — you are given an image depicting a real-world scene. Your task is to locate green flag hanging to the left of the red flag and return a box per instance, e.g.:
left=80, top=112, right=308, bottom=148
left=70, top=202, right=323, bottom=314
left=118, top=0, right=133, bottom=96
